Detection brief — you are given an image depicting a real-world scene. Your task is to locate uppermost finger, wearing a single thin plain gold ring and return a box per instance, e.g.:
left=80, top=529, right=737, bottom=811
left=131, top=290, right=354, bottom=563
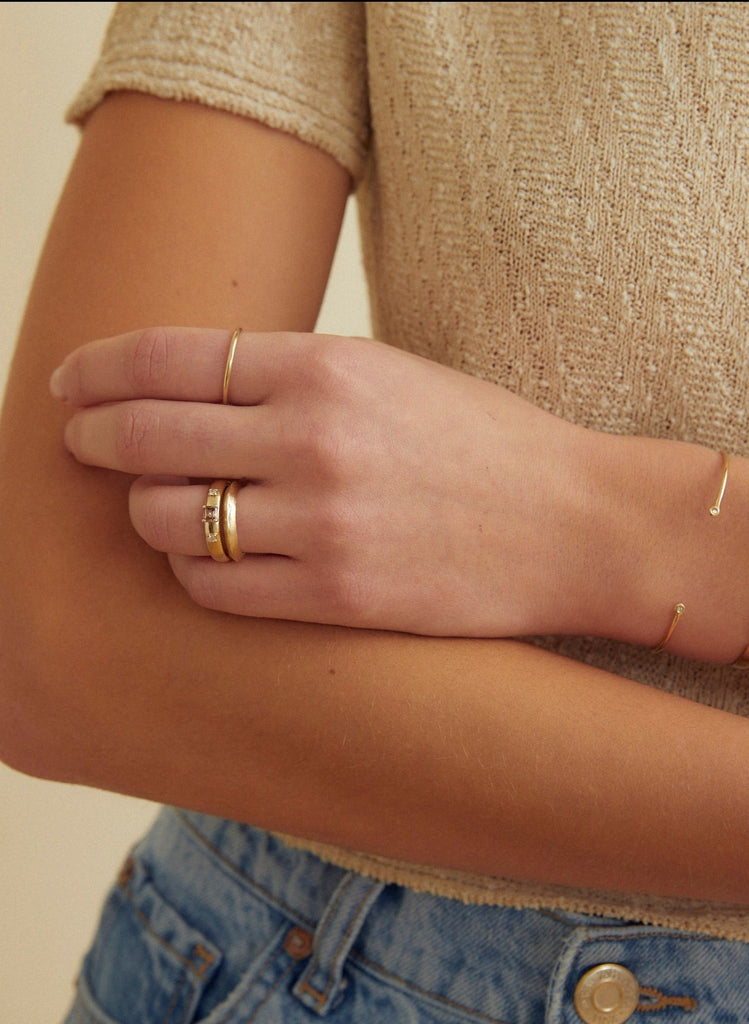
left=49, top=328, right=278, bottom=406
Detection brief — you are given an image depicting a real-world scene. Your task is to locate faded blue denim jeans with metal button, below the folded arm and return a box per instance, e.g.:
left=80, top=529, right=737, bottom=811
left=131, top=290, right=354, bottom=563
left=66, top=809, right=749, bottom=1024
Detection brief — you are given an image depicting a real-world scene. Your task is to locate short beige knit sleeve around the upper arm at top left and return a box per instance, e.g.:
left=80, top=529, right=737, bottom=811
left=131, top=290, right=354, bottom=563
left=68, top=2, right=369, bottom=180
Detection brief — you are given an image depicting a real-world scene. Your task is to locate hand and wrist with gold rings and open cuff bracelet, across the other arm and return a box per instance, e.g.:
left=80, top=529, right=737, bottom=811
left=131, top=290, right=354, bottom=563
left=45, top=329, right=749, bottom=662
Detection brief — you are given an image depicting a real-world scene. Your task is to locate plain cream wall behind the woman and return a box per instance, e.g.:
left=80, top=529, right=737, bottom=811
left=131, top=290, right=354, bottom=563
left=0, top=2, right=369, bottom=1024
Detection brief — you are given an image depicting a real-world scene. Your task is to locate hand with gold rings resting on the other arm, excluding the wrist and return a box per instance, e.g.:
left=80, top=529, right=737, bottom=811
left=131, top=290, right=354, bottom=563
left=53, top=329, right=588, bottom=636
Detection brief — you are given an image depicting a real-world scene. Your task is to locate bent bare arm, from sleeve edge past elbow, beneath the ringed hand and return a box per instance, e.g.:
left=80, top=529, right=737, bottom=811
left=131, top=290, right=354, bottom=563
left=0, top=95, right=749, bottom=905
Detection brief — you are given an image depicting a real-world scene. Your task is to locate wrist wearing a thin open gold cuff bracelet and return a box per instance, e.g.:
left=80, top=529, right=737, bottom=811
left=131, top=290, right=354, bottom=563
left=561, top=432, right=749, bottom=663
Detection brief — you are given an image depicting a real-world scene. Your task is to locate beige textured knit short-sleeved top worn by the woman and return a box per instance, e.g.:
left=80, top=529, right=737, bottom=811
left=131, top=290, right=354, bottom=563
left=70, top=3, right=749, bottom=940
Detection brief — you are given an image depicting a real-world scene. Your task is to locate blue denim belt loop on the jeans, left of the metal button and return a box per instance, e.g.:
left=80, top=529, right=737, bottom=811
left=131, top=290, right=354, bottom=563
left=293, top=871, right=384, bottom=1017
